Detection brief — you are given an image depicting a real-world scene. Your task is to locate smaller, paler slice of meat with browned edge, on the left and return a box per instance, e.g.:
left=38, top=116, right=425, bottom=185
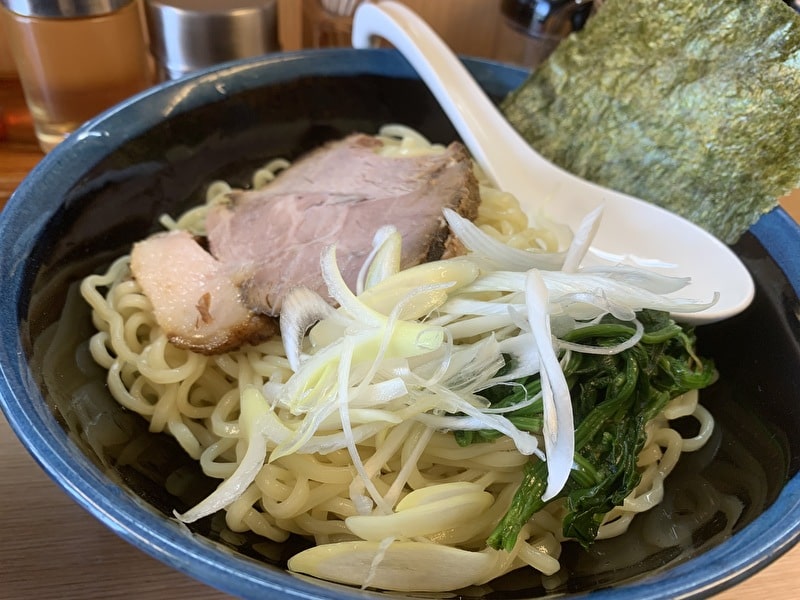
left=131, top=231, right=278, bottom=354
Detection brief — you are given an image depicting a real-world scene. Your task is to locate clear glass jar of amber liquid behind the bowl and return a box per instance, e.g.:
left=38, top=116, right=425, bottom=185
left=2, top=2, right=153, bottom=152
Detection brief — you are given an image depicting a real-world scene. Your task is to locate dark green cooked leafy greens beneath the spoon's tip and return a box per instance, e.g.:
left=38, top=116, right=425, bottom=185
left=466, top=311, right=715, bottom=550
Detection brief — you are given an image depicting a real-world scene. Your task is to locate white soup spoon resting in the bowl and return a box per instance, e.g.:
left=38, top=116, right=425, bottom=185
left=352, top=0, right=755, bottom=324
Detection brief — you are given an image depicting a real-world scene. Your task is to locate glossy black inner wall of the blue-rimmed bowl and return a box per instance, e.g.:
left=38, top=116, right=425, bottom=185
left=15, top=59, right=800, bottom=598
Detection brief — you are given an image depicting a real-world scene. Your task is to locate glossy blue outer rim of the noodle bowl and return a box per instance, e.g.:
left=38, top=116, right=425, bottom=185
left=0, top=49, right=800, bottom=600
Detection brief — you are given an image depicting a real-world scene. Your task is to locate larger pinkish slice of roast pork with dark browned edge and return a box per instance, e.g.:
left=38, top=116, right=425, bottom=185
left=206, top=134, right=480, bottom=315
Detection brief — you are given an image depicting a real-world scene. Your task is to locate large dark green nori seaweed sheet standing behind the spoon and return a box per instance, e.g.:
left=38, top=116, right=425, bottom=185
left=501, top=0, right=800, bottom=243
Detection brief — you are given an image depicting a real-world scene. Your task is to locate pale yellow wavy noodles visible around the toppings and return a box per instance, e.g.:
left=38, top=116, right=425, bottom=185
left=81, top=126, right=720, bottom=584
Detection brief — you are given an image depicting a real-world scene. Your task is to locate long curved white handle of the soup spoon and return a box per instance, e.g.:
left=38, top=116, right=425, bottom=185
left=352, top=2, right=552, bottom=204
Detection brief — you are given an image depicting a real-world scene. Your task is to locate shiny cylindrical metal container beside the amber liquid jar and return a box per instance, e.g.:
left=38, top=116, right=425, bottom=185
left=146, top=0, right=278, bottom=78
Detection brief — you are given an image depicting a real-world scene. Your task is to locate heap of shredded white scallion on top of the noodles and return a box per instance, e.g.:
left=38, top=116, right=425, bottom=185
left=178, top=200, right=715, bottom=540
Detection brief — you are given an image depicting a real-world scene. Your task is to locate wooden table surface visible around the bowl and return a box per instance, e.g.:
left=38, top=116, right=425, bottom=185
left=0, top=81, right=800, bottom=600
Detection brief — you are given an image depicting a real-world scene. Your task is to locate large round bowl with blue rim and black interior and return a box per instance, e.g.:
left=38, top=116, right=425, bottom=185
left=0, top=49, right=800, bottom=599
